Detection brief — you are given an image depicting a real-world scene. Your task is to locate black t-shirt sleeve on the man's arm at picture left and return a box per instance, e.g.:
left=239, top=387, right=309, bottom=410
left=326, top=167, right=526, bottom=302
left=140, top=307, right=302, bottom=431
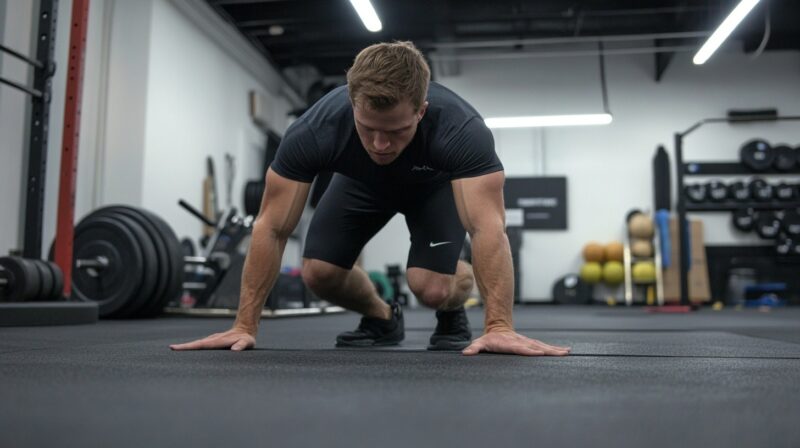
left=270, top=122, right=324, bottom=183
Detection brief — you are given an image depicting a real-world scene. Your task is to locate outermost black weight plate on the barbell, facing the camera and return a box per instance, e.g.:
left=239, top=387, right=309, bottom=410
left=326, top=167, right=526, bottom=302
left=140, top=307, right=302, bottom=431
left=72, top=216, right=144, bottom=317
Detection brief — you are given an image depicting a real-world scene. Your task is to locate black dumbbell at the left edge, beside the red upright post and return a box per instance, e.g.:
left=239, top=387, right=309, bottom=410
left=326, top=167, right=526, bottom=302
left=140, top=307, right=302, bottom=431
left=0, top=257, right=64, bottom=302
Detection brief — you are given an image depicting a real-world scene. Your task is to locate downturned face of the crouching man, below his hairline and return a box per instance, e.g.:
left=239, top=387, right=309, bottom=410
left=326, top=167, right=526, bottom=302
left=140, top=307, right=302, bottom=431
left=353, top=101, right=428, bottom=165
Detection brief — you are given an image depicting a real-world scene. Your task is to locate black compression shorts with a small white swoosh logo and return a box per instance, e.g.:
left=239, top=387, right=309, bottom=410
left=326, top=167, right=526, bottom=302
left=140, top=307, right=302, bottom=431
left=303, top=174, right=466, bottom=275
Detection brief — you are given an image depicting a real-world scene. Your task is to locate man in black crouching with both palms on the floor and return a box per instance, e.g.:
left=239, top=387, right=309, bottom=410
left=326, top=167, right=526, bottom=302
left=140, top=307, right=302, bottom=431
left=171, top=42, right=570, bottom=356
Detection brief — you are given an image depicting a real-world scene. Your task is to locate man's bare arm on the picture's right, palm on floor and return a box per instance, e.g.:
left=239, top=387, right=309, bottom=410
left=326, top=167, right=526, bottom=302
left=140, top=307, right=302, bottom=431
left=452, top=171, right=570, bottom=356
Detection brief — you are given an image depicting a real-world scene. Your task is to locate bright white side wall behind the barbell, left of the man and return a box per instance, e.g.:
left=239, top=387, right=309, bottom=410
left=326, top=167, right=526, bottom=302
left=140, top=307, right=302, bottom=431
left=141, top=1, right=290, bottom=245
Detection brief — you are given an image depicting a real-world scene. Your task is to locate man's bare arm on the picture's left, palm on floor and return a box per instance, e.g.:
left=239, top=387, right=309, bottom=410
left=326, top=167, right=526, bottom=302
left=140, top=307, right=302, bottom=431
left=170, top=169, right=311, bottom=350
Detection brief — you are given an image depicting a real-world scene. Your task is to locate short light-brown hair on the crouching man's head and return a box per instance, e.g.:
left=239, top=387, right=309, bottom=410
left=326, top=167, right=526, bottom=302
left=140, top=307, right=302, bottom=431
left=347, top=41, right=431, bottom=111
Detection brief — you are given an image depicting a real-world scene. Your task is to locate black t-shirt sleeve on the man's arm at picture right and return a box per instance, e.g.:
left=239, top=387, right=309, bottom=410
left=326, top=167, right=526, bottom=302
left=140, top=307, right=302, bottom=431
left=444, top=117, right=503, bottom=179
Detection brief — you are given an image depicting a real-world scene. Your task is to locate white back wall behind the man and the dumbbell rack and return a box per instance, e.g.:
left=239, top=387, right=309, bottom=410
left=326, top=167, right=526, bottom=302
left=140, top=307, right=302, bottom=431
left=365, top=50, right=800, bottom=300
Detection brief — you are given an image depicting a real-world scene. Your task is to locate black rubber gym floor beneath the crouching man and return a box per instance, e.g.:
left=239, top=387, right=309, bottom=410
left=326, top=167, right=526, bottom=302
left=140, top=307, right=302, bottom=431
left=0, top=306, right=800, bottom=448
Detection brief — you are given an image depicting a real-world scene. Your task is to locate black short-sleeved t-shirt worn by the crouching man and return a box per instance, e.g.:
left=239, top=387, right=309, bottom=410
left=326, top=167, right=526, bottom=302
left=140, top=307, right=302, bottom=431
left=271, top=82, right=503, bottom=196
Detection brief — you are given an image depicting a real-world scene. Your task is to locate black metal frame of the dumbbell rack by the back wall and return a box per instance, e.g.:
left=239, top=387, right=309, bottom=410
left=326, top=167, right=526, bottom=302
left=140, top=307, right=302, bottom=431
left=674, top=115, right=800, bottom=305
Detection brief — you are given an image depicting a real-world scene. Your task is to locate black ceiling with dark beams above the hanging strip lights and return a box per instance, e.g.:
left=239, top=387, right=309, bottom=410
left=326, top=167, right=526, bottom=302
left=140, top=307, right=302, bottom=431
left=207, top=0, right=800, bottom=76
